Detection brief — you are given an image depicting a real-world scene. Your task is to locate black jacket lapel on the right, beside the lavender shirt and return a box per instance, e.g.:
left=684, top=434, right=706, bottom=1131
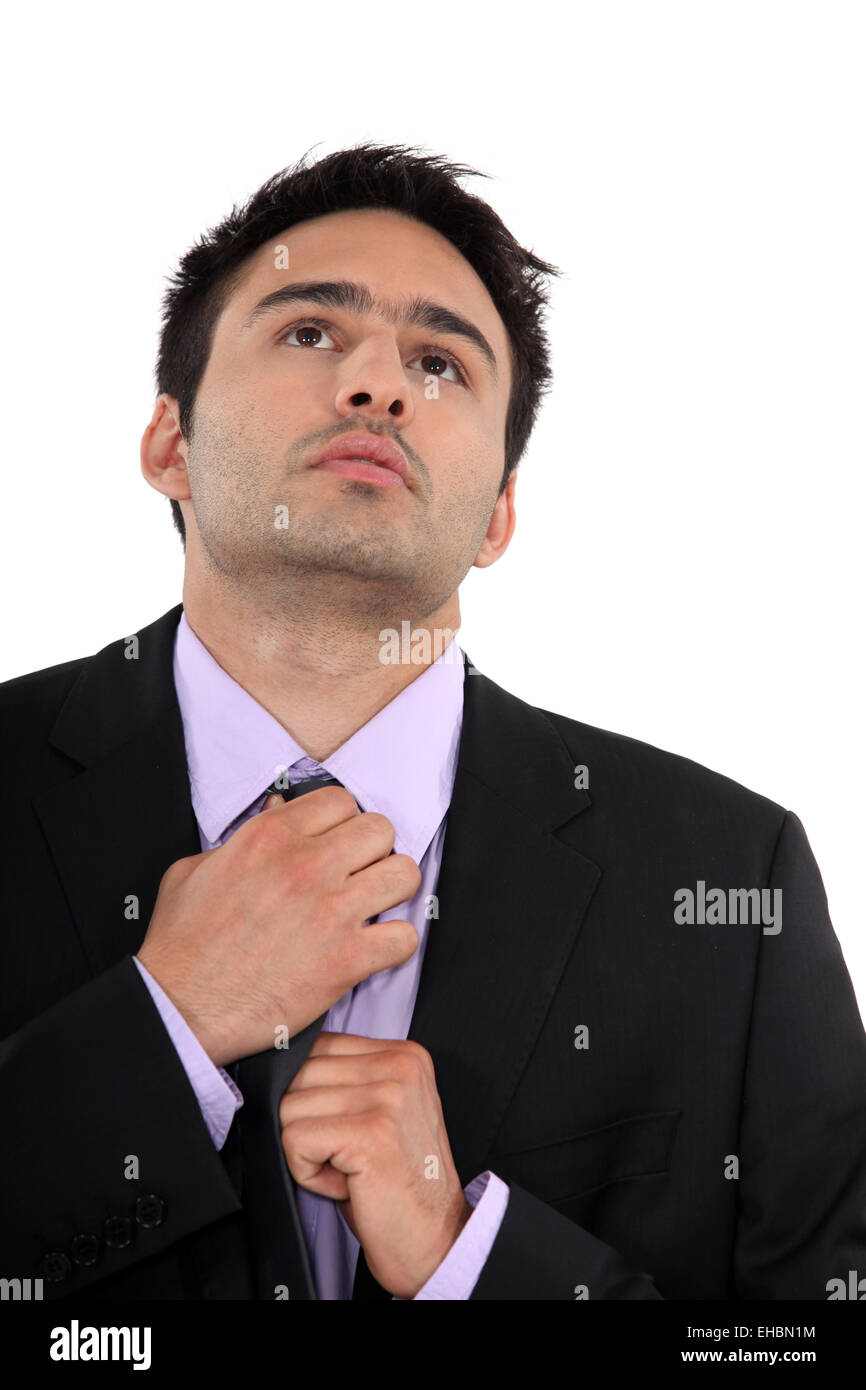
left=409, top=663, right=601, bottom=1184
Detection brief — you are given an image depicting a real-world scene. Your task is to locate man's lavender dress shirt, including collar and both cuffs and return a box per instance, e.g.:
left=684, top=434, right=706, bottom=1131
left=135, top=613, right=509, bottom=1301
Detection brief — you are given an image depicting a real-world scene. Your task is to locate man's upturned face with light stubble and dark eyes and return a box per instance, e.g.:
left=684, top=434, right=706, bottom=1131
left=173, top=209, right=512, bottom=619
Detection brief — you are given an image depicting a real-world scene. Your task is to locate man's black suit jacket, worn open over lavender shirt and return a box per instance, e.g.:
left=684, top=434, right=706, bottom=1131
left=0, top=605, right=866, bottom=1300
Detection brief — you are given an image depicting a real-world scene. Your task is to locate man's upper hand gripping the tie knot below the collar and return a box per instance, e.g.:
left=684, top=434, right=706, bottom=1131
left=136, top=787, right=421, bottom=1066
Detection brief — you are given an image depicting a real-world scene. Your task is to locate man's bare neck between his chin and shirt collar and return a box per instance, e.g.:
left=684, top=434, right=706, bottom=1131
left=183, top=575, right=460, bottom=762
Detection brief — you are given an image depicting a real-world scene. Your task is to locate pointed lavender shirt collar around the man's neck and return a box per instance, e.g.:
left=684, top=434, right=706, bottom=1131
left=174, top=613, right=464, bottom=863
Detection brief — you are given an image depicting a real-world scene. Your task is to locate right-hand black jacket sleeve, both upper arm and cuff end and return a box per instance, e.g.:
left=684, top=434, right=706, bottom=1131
left=471, top=812, right=866, bottom=1300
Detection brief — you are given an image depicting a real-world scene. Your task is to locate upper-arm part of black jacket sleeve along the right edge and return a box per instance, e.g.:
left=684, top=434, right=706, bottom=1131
left=734, top=812, right=866, bottom=1300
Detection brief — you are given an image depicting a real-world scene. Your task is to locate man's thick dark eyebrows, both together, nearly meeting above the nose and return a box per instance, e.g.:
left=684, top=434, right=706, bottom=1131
left=240, top=279, right=498, bottom=381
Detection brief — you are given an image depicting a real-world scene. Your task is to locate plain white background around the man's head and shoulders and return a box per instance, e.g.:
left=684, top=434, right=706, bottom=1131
left=0, top=0, right=866, bottom=1015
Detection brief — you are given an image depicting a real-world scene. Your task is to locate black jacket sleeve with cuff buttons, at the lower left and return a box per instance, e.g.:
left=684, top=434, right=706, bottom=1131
left=0, top=956, right=240, bottom=1298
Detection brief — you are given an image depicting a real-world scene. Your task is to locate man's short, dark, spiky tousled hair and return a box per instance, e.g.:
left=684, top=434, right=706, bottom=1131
left=156, top=142, right=560, bottom=549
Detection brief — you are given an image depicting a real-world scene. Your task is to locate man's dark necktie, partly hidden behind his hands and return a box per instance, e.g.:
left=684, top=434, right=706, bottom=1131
left=237, top=774, right=342, bottom=1302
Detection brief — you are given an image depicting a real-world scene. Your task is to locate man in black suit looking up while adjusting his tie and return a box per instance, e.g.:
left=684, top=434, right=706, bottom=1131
left=0, top=146, right=866, bottom=1300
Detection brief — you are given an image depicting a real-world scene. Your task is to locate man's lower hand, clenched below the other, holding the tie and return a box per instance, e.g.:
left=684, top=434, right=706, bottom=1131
left=279, top=1033, right=473, bottom=1298
